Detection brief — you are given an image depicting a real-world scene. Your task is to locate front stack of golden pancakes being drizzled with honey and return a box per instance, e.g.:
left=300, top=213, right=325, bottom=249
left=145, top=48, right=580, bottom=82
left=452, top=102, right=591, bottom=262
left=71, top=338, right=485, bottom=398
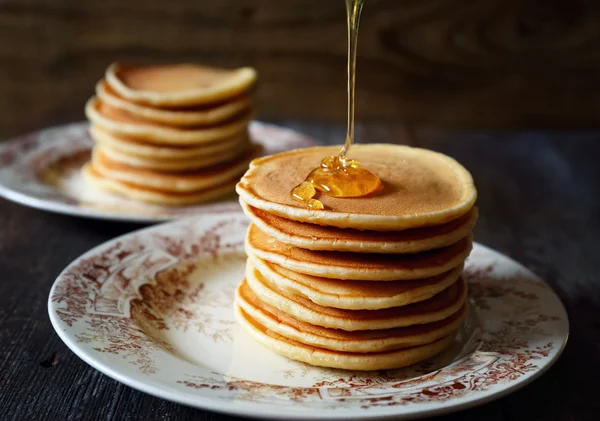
left=234, top=145, right=477, bottom=370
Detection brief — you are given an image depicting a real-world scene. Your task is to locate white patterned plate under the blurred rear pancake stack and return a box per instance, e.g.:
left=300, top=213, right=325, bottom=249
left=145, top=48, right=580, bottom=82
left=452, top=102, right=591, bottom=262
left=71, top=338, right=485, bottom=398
left=0, top=122, right=315, bottom=222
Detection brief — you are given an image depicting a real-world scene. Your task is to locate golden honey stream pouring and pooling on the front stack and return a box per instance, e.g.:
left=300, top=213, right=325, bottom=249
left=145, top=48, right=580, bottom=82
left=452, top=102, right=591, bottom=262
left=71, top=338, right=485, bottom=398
left=291, top=0, right=381, bottom=210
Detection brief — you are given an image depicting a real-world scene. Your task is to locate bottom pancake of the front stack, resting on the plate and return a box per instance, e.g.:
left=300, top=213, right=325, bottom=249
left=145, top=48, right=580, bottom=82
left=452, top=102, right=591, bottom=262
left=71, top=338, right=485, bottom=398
left=234, top=305, right=454, bottom=371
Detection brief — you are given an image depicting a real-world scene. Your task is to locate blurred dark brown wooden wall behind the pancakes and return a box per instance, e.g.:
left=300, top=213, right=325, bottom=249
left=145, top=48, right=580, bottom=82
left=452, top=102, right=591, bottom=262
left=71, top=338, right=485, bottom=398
left=0, top=0, right=600, bottom=138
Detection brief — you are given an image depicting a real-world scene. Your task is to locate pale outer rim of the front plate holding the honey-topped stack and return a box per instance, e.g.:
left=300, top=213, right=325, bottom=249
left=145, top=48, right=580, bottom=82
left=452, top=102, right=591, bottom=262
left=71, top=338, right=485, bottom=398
left=48, top=215, right=569, bottom=420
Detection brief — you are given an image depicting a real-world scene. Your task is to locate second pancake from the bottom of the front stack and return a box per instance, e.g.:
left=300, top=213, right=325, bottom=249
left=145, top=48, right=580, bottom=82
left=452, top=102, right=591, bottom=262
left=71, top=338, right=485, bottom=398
left=235, top=283, right=467, bottom=353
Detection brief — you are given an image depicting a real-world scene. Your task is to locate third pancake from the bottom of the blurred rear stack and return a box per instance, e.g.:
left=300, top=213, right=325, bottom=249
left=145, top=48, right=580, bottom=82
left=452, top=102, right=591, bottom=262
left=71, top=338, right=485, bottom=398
left=96, top=142, right=251, bottom=172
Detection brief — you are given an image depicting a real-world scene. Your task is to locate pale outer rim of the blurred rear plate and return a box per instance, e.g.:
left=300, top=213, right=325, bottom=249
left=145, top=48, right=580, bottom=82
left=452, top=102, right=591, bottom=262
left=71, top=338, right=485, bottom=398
left=0, top=120, right=317, bottom=224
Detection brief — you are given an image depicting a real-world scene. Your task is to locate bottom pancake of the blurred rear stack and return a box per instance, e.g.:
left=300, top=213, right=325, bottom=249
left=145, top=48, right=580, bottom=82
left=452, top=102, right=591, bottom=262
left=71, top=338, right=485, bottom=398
left=82, top=163, right=237, bottom=206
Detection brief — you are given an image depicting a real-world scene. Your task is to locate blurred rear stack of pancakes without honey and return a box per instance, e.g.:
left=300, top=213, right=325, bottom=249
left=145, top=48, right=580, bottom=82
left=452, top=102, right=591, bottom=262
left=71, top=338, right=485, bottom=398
left=83, top=64, right=259, bottom=205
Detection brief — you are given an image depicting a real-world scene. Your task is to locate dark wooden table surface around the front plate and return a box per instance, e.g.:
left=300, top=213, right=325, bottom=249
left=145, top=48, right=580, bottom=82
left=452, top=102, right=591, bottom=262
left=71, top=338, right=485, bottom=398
left=0, top=120, right=600, bottom=421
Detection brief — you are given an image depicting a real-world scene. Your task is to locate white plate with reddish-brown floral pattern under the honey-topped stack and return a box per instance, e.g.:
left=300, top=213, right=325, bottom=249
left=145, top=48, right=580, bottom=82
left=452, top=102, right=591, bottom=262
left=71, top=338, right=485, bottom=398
left=48, top=213, right=569, bottom=419
